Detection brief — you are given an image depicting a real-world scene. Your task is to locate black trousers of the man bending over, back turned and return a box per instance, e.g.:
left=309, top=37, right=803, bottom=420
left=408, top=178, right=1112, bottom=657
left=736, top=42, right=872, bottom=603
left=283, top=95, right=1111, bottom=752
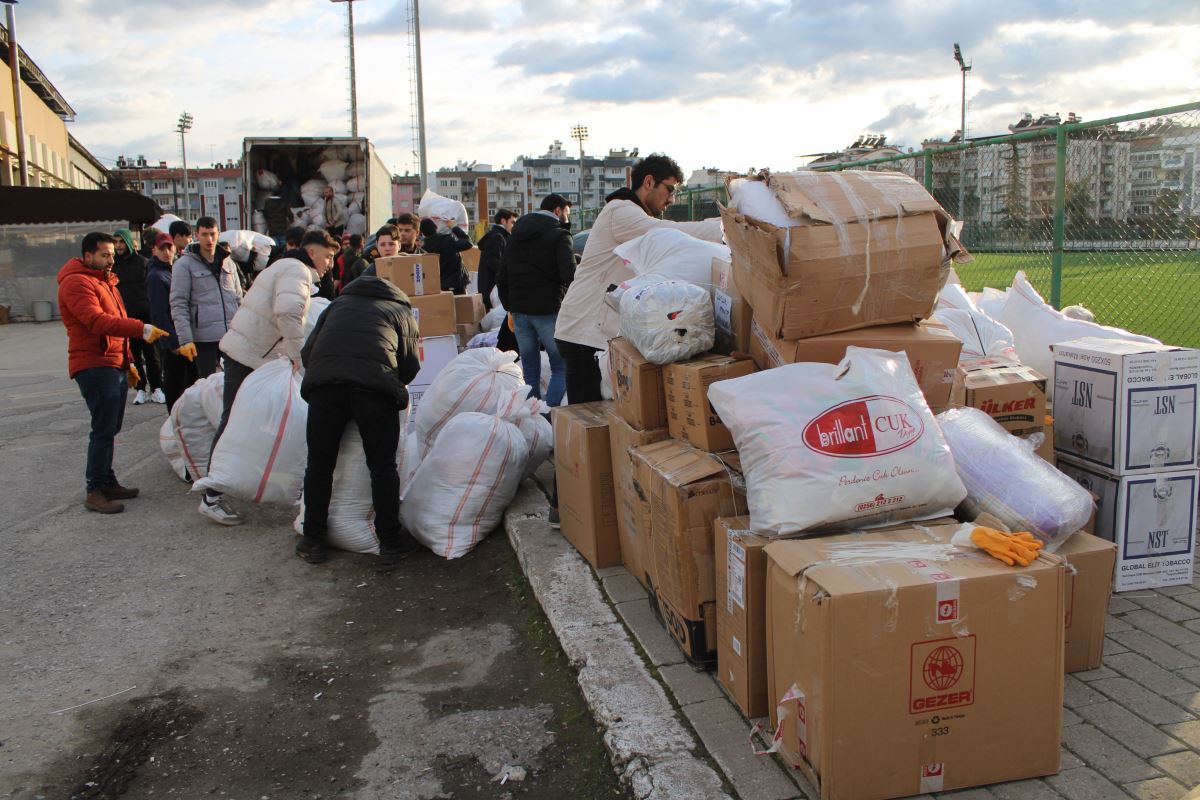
left=304, top=384, right=401, bottom=548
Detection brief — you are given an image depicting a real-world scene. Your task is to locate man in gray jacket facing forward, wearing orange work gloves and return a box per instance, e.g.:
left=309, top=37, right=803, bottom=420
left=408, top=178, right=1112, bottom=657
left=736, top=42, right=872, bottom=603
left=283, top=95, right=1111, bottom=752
left=170, top=217, right=244, bottom=378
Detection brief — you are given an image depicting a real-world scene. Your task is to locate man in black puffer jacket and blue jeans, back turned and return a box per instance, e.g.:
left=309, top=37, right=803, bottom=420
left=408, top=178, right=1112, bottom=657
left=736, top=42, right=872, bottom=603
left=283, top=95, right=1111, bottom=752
left=496, top=194, right=575, bottom=405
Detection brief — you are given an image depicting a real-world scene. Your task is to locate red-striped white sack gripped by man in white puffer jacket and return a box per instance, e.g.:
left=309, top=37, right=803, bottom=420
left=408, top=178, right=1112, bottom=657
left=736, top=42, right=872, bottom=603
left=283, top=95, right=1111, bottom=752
left=192, top=359, right=308, bottom=505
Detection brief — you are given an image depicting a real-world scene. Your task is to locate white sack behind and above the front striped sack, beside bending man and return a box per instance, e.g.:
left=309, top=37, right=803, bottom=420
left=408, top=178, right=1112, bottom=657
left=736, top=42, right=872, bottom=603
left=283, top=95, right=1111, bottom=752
left=416, top=348, right=529, bottom=453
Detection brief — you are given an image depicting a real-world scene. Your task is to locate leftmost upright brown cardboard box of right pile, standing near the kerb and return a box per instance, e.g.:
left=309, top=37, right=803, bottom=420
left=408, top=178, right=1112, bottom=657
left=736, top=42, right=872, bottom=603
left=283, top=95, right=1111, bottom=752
left=551, top=401, right=620, bottom=570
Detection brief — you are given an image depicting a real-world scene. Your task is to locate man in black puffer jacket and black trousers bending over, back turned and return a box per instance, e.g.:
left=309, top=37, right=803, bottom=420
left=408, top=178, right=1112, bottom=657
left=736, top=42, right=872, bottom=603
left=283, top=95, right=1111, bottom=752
left=296, top=275, right=421, bottom=564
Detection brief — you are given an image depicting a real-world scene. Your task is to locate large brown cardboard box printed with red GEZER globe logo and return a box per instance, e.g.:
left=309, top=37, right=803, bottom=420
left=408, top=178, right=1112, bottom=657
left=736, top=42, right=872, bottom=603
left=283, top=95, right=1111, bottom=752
left=767, top=525, right=1066, bottom=800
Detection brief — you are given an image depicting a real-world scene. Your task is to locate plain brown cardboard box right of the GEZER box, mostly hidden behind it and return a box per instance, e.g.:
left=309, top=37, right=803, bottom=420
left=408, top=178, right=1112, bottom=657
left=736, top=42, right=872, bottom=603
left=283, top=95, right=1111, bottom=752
left=1056, top=531, right=1117, bottom=672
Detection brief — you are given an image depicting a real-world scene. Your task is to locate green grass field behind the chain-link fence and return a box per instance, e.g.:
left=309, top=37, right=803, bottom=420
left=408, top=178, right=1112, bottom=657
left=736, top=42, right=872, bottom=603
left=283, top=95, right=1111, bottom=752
left=955, top=251, right=1200, bottom=348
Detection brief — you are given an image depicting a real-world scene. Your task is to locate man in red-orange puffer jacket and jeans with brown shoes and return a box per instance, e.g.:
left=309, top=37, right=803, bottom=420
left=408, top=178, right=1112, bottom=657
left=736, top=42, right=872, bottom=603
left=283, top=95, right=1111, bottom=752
left=59, top=233, right=167, bottom=513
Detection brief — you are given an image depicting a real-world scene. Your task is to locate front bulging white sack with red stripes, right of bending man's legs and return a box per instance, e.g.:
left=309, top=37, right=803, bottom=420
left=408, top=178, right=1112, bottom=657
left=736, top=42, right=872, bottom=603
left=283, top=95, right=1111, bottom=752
left=401, top=401, right=529, bottom=559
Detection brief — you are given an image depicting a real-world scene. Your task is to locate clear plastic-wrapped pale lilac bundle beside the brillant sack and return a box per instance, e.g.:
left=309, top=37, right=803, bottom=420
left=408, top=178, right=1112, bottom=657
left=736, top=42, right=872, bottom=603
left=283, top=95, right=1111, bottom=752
left=937, top=408, right=1092, bottom=552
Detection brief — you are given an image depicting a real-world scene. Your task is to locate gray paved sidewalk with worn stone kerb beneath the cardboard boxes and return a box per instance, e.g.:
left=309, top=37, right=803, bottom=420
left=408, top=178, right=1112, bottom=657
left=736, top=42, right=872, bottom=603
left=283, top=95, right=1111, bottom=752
left=505, top=467, right=1200, bottom=800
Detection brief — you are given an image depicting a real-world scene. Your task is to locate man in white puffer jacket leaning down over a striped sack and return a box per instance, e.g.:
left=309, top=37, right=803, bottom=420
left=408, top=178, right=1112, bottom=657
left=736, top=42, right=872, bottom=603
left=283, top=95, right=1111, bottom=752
left=200, top=230, right=340, bottom=525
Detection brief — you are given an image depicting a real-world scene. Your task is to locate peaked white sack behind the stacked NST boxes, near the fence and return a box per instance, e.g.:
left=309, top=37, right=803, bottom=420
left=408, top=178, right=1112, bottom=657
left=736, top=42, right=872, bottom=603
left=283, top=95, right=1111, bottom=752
left=1001, top=272, right=1160, bottom=377
